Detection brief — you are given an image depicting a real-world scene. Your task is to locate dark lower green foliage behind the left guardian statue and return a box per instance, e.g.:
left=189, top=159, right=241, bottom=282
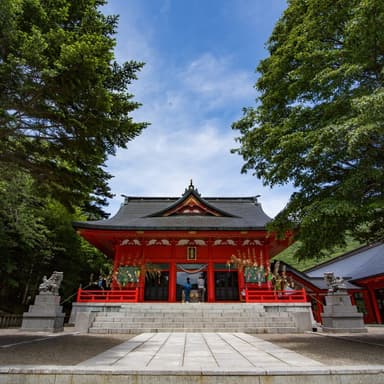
left=0, top=167, right=111, bottom=312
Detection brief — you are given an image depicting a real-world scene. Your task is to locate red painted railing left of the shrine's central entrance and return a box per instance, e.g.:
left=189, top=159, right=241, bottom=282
left=76, top=287, right=139, bottom=303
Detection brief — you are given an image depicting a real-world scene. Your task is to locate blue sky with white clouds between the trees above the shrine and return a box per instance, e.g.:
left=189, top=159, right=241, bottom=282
left=103, top=0, right=292, bottom=217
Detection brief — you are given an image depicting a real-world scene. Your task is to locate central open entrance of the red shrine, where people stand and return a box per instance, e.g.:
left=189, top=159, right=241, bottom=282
left=176, top=264, right=207, bottom=302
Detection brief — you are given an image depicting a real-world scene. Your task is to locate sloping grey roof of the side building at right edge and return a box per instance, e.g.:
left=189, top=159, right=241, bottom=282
left=306, top=243, right=384, bottom=281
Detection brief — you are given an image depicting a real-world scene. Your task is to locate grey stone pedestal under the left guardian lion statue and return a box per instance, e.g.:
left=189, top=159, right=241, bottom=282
left=21, top=293, right=65, bottom=332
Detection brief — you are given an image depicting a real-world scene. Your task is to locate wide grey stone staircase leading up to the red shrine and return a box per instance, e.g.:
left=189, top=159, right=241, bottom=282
left=89, top=303, right=302, bottom=334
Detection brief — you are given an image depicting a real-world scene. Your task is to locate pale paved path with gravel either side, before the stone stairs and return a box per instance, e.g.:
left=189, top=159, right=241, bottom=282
left=0, top=327, right=384, bottom=368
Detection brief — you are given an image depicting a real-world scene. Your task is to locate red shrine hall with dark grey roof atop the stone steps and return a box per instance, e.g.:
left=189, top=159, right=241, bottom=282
left=74, top=181, right=306, bottom=303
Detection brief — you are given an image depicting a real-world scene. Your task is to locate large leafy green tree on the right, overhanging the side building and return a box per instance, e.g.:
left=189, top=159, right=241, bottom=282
left=233, top=0, right=384, bottom=257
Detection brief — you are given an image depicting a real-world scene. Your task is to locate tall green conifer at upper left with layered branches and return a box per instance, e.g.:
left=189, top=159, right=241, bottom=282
left=0, top=0, right=147, bottom=214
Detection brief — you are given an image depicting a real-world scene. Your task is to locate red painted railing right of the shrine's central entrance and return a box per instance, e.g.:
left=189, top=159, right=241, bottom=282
left=245, top=288, right=307, bottom=303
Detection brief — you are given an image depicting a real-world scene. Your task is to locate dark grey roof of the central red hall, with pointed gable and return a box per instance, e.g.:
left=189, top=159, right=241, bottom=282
left=73, top=183, right=271, bottom=230
